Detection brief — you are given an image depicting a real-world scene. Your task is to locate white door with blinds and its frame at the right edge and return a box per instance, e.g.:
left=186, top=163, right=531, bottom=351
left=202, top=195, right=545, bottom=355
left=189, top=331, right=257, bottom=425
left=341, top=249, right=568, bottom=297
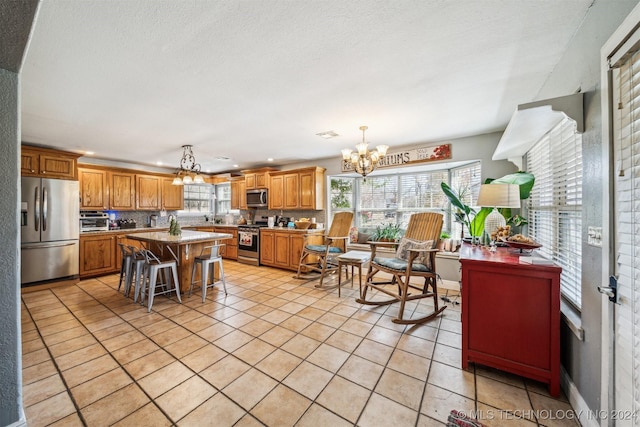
left=601, top=8, right=640, bottom=427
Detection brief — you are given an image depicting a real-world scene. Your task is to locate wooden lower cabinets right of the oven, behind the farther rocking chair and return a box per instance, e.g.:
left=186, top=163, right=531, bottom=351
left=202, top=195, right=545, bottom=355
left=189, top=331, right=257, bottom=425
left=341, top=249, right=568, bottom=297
left=260, top=228, right=324, bottom=270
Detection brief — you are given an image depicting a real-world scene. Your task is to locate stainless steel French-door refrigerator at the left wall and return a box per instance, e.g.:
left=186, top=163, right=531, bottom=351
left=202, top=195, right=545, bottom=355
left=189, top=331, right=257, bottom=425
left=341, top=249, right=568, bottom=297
left=20, top=177, right=80, bottom=286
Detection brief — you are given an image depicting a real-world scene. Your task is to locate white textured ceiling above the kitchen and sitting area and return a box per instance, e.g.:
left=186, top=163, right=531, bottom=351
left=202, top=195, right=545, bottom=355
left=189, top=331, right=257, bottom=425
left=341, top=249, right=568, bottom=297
left=22, top=0, right=593, bottom=172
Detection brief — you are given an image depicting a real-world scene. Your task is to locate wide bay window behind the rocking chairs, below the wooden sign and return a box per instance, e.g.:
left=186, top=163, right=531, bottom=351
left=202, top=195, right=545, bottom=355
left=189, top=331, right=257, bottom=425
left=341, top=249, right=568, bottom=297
left=329, top=162, right=481, bottom=236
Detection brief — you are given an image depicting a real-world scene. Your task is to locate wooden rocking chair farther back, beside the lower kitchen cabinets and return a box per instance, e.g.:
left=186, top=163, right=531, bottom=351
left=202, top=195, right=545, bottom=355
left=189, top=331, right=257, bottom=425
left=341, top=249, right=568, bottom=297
left=296, top=212, right=353, bottom=287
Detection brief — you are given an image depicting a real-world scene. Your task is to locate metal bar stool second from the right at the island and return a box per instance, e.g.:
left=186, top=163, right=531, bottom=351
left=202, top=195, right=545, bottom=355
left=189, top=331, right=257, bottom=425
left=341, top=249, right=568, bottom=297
left=140, top=249, right=182, bottom=313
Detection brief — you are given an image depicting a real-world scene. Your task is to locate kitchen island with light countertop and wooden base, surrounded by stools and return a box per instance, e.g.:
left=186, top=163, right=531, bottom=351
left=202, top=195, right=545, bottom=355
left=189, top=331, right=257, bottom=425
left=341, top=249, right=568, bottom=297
left=126, top=230, right=233, bottom=293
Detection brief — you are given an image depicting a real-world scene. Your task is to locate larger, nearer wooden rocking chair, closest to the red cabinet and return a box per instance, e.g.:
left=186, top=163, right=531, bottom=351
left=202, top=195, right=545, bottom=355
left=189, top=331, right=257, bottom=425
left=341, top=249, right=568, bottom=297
left=356, top=212, right=446, bottom=324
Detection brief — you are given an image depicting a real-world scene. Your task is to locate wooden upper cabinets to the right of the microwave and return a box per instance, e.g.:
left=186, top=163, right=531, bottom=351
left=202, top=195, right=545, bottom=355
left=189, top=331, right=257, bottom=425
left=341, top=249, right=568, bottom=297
left=269, top=167, right=325, bottom=210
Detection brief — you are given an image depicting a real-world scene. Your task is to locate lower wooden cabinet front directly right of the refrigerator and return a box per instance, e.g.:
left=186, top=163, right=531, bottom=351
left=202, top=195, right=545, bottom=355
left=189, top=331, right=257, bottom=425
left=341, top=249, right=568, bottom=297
left=80, top=235, right=118, bottom=277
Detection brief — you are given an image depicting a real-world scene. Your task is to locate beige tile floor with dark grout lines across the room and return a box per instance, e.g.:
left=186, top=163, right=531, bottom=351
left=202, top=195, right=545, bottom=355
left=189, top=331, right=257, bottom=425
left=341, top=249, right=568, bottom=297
left=22, top=261, right=578, bottom=427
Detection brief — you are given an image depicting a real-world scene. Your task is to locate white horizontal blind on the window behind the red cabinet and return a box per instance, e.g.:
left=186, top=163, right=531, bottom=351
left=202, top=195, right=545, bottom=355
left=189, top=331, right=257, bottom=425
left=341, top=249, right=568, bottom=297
left=526, top=119, right=582, bottom=309
